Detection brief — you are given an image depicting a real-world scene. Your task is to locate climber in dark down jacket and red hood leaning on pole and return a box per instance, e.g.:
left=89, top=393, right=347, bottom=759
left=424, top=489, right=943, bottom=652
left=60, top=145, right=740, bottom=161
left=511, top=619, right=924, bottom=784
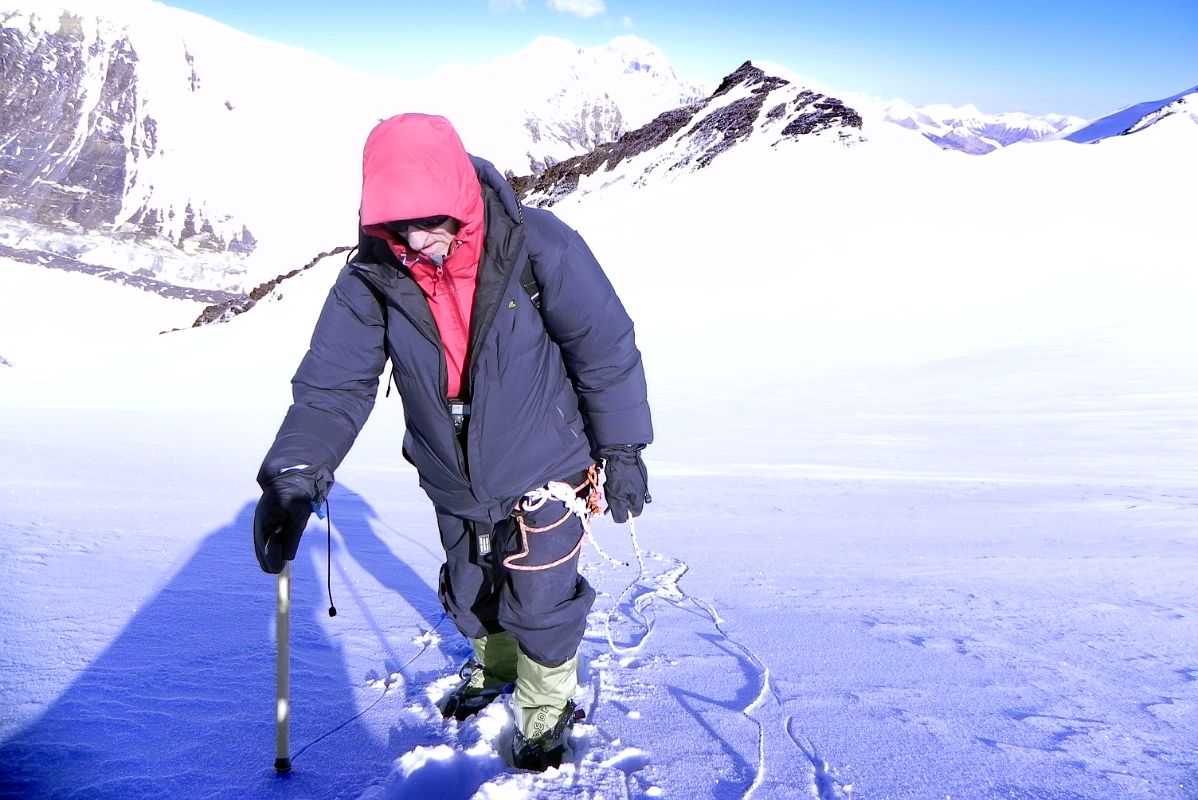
left=246, top=114, right=653, bottom=768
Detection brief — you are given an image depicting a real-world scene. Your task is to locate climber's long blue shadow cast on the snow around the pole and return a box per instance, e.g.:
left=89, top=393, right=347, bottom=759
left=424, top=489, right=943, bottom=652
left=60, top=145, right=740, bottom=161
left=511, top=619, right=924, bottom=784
left=0, top=486, right=458, bottom=800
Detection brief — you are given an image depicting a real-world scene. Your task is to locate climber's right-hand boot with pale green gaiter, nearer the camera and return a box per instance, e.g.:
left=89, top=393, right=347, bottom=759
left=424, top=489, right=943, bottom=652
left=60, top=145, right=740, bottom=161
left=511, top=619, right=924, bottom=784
left=512, top=650, right=585, bottom=772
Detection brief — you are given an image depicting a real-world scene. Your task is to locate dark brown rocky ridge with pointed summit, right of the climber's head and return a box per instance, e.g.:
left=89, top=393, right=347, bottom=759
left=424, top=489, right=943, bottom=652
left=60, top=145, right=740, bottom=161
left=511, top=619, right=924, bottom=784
left=513, top=61, right=865, bottom=206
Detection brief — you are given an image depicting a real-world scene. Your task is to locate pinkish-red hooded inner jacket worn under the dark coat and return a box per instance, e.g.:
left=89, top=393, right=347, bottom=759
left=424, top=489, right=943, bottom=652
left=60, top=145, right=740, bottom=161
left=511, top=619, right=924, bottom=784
left=361, top=114, right=485, bottom=398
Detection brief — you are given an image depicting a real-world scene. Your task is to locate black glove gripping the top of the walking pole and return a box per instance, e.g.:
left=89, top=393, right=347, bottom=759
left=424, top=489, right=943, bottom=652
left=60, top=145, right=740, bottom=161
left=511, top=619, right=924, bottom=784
left=254, top=467, right=333, bottom=575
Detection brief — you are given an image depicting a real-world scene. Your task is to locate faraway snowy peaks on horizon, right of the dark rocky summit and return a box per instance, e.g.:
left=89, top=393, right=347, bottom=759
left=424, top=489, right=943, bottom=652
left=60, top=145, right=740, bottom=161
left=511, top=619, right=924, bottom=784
left=882, top=101, right=1083, bottom=156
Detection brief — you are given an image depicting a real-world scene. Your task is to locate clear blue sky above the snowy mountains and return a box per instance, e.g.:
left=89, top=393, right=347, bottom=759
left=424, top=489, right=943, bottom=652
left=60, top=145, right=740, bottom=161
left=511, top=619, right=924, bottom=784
left=167, top=0, right=1198, bottom=117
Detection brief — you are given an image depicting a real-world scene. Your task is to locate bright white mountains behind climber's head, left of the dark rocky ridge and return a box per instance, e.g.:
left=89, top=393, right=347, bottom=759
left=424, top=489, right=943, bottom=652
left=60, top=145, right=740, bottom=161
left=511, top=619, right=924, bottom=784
left=0, top=0, right=701, bottom=292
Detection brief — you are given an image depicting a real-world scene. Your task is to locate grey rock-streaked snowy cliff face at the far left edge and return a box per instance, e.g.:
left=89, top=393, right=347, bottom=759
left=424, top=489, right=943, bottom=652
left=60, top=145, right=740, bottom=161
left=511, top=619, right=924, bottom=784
left=0, top=6, right=267, bottom=289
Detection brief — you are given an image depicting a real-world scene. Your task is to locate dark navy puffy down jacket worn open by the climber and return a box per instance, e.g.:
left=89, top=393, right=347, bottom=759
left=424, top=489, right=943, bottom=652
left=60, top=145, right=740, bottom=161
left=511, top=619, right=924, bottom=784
left=259, top=158, right=653, bottom=523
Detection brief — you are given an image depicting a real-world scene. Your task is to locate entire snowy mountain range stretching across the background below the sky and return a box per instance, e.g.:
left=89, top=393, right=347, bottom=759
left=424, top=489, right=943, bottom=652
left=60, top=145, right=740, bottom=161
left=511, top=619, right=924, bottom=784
left=0, top=0, right=1198, bottom=308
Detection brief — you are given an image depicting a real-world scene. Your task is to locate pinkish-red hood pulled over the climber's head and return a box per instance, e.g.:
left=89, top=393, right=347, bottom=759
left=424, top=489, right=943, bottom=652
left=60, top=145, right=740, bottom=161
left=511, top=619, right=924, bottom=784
left=361, top=114, right=483, bottom=228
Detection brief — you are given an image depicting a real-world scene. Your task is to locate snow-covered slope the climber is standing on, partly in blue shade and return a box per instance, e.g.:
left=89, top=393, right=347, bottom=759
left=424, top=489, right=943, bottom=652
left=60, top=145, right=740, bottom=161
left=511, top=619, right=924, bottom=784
left=0, top=107, right=1198, bottom=800
